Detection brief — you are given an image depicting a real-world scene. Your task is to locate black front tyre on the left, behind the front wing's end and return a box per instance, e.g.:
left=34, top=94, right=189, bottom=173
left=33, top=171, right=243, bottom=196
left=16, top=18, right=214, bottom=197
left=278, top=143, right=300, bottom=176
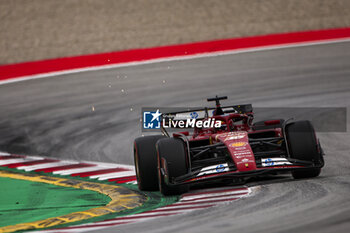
left=156, top=138, right=188, bottom=196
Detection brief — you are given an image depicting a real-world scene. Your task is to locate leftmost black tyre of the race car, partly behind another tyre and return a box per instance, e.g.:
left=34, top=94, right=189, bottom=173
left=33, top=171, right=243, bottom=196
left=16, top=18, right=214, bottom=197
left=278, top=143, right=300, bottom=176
left=134, top=135, right=165, bottom=191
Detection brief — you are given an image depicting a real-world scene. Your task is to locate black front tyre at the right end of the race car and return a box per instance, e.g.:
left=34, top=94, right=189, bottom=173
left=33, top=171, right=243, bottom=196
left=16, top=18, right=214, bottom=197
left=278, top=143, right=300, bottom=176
left=286, top=121, right=323, bottom=179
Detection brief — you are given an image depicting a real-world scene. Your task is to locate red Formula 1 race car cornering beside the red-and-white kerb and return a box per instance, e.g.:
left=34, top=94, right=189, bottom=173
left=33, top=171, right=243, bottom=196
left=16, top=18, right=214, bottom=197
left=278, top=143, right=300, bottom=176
left=134, top=96, right=324, bottom=195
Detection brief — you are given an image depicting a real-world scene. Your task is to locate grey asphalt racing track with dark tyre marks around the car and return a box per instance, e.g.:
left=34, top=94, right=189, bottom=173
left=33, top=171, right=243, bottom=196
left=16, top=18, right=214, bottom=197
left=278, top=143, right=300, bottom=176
left=0, top=42, right=350, bottom=232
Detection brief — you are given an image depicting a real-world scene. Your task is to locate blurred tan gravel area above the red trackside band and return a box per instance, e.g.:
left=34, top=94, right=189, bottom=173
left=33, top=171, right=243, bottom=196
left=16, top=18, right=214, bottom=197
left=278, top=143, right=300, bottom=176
left=0, top=0, right=350, bottom=64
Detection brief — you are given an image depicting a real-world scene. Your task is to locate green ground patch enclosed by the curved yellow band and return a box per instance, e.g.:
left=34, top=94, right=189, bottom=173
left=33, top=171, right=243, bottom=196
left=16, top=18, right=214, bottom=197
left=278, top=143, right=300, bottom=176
left=0, top=177, right=111, bottom=227
